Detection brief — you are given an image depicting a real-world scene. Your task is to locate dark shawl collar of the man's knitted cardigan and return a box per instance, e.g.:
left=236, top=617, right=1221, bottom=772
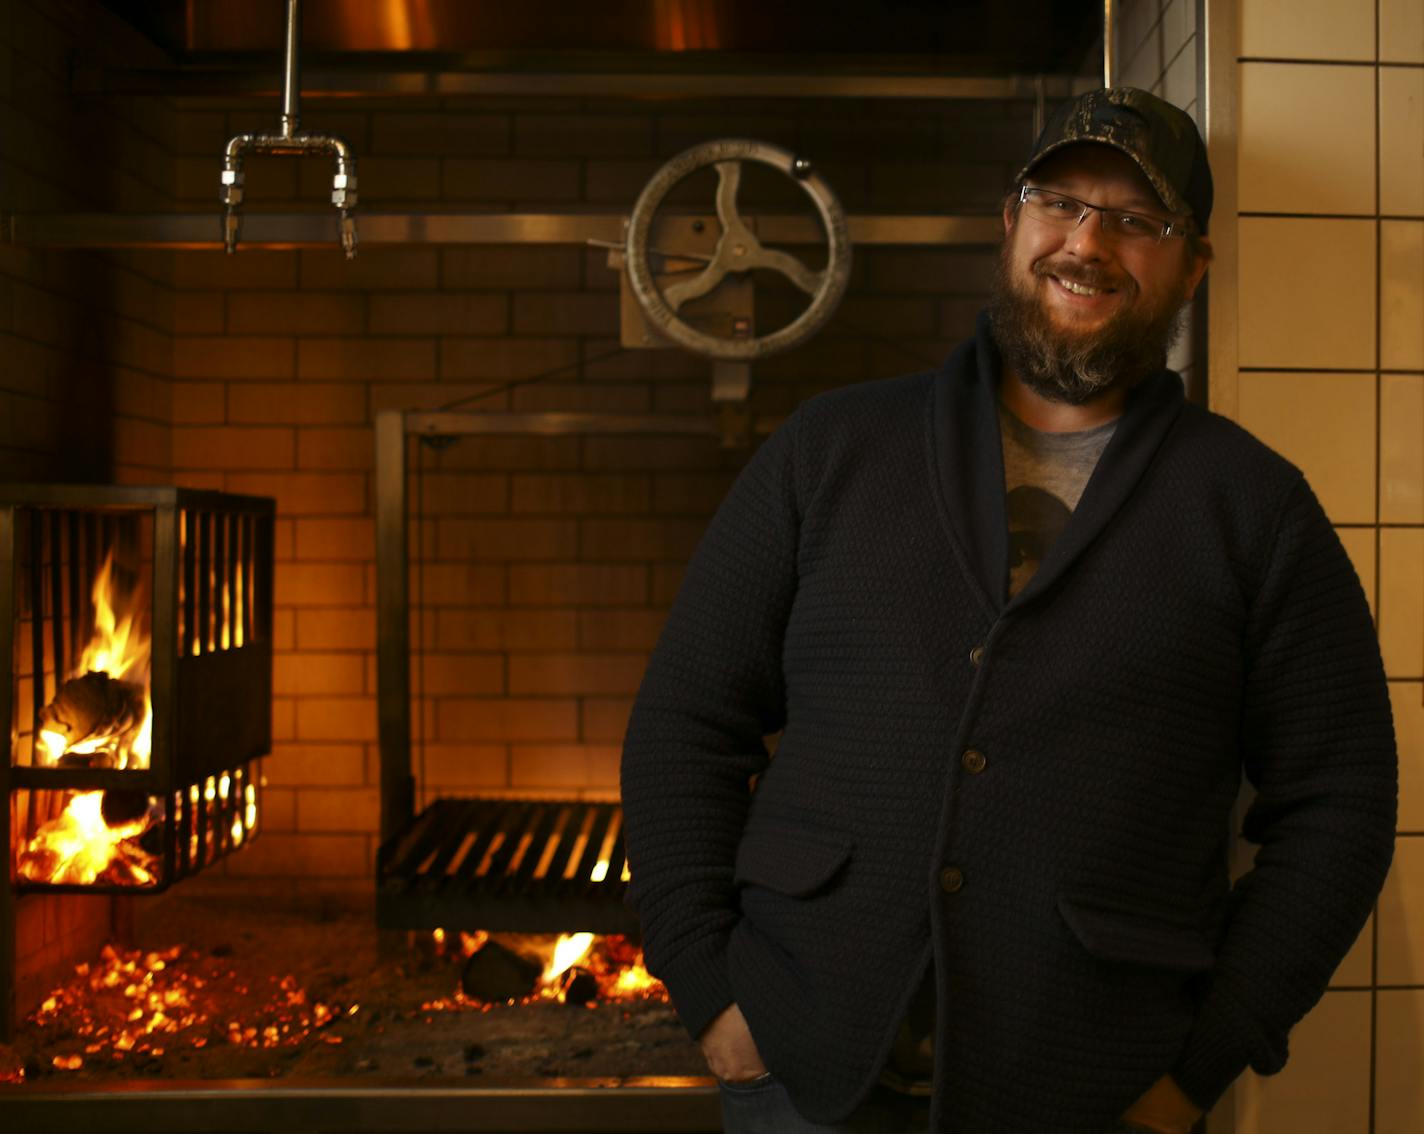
left=933, top=312, right=1185, bottom=611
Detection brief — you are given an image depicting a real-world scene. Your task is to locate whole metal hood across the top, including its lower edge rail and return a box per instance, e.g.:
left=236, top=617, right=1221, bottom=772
left=89, top=0, right=1102, bottom=98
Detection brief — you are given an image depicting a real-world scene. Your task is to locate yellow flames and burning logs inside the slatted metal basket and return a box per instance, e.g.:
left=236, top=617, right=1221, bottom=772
left=17, top=551, right=157, bottom=886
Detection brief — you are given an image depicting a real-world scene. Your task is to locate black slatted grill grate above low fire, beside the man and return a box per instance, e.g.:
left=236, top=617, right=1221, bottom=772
left=376, top=799, right=638, bottom=933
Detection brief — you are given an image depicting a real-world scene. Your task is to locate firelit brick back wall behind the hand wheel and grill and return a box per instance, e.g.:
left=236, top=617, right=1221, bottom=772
left=155, top=98, right=1031, bottom=879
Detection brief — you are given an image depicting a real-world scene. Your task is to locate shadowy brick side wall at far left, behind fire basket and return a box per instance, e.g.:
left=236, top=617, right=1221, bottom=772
left=0, top=0, right=171, bottom=1006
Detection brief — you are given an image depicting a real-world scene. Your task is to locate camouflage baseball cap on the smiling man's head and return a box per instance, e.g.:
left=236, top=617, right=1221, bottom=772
left=1017, top=87, right=1212, bottom=232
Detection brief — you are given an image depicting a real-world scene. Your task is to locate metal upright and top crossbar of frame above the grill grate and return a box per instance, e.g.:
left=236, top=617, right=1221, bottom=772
left=376, top=410, right=721, bottom=846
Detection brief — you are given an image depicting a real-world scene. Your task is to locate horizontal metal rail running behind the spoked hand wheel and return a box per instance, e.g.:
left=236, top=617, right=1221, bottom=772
left=0, top=211, right=1002, bottom=251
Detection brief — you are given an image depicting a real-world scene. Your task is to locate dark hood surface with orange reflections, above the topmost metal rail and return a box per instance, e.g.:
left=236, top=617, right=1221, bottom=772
left=103, top=0, right=1102, bottom=76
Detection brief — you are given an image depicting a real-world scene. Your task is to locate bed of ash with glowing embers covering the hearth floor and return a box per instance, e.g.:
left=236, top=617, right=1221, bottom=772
left=0, top=878, right=708, bottom=1088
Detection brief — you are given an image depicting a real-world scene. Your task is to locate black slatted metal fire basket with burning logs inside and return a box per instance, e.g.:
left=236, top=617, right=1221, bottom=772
left=0, top=484, right=275, bottom=1017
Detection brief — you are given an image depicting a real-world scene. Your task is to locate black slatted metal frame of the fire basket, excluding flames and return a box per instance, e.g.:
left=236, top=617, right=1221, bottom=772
left=0, top=484, right=276, bottom=1041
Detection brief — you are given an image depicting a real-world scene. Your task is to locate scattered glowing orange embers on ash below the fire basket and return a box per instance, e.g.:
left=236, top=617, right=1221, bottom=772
left=9, top=945, right=347, bottom=1081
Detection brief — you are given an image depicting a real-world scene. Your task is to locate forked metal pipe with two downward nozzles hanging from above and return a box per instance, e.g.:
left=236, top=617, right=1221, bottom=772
left=222, top=0, right=356, bottom=259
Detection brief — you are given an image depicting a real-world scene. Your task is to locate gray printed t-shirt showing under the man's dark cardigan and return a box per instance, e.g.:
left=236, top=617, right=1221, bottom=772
left=881, top=405, right=1118, bottom=1094
